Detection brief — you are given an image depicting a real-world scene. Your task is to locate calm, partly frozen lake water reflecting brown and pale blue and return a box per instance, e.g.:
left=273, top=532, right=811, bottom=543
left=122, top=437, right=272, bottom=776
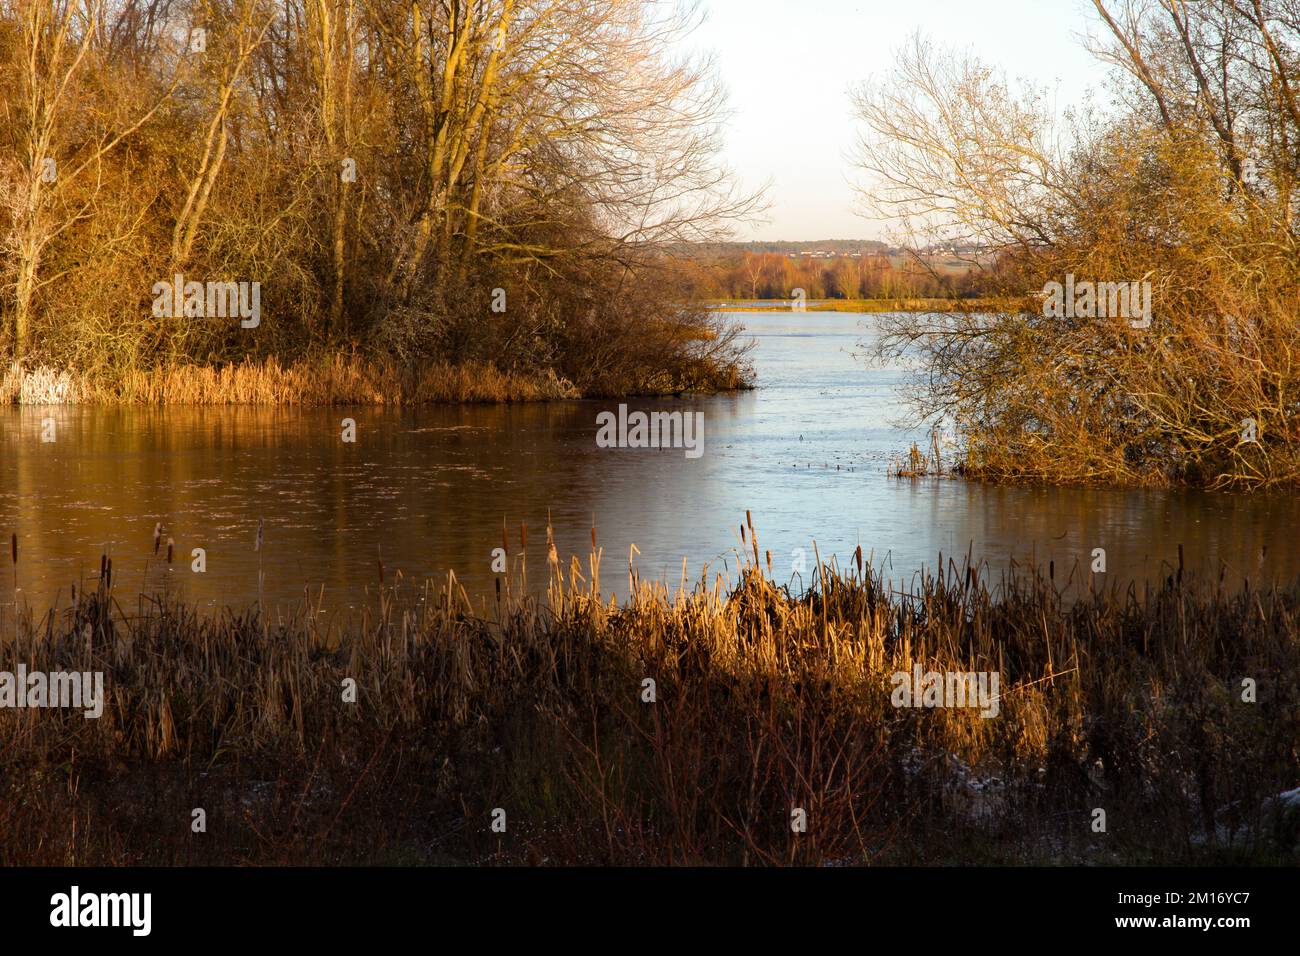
left=0, top=312, right=1300, bottom=609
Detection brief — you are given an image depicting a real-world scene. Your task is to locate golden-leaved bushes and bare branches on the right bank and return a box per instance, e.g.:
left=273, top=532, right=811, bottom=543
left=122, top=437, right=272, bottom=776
left=857, top=0, right=1300, bottom=488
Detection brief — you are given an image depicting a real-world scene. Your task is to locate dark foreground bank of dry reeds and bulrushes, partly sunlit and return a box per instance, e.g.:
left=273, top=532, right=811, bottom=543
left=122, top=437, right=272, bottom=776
left=0, top=529, right=1300, bottom=865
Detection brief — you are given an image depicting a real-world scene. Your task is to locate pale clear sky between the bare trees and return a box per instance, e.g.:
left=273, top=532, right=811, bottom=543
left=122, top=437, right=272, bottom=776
left=690, top=0, right=1102, bottom=241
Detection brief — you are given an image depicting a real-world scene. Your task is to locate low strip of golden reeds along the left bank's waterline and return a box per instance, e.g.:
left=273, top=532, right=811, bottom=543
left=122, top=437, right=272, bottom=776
left=0, top=354, right=577, bottom=406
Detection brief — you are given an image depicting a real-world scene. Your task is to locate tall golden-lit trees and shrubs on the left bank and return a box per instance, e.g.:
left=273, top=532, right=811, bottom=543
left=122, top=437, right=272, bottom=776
left=0, top=0, right=754, bottom=402
